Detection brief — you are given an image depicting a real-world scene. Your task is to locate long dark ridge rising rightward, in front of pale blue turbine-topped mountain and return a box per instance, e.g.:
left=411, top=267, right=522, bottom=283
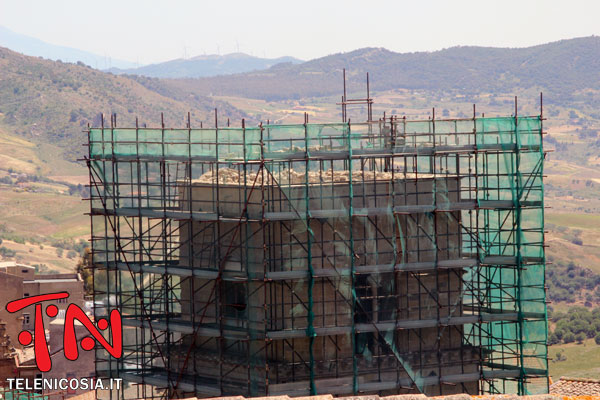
left=136, top=36, right=600, bottom=101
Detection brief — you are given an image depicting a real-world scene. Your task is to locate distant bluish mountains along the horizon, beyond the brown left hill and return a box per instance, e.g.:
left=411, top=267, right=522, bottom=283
left=0, top=27, right=600, bottom=106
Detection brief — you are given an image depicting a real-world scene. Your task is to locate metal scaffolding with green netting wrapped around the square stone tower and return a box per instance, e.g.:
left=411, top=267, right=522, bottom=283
left=87, top=99, right=548, bottom=398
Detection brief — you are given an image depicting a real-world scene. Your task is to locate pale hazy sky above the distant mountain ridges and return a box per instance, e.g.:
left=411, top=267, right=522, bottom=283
left=0, top=0, right=600, bottom=64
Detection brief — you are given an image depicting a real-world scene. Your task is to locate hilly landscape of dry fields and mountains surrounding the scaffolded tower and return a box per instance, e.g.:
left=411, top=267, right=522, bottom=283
left=0, top=38, right=600, bottom=382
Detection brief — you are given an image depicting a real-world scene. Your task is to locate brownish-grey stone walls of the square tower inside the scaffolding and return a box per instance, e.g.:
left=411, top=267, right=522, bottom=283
left=172, top=177, right=479, bottom=394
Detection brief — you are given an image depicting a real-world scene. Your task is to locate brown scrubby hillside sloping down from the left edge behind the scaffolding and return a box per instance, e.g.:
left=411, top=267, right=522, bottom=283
left=0, top=48, right=243, bottom=166
